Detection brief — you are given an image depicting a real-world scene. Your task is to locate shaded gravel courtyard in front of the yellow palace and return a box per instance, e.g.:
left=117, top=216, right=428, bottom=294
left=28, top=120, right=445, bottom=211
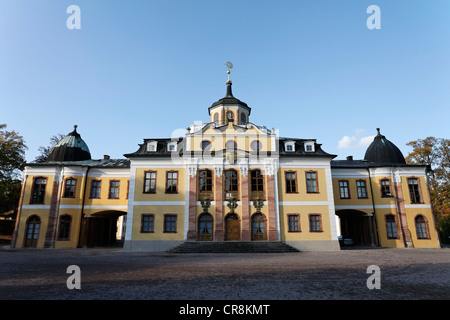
left=0, top=248, right=450, bottom=300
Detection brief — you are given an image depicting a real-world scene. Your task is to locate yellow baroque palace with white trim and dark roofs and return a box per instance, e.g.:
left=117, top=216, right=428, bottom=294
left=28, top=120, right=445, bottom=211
left=11, top=74, right=440, bottom=251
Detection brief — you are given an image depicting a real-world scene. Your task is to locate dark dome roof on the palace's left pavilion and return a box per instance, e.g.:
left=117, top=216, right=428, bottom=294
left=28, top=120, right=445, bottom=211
left=47, top=125, right=91, bottom=162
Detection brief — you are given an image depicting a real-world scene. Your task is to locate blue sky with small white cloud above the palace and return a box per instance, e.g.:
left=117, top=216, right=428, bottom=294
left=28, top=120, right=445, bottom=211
left=0, top=0, right=450, bottom=161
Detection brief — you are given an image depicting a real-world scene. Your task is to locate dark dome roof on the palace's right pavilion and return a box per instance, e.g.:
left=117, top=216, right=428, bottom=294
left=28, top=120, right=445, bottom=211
left=364, top=128, right=406, bottom=164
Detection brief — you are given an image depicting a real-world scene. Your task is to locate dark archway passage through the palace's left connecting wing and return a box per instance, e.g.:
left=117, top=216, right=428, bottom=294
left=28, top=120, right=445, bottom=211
left=79, top=211, right=126, bottom=248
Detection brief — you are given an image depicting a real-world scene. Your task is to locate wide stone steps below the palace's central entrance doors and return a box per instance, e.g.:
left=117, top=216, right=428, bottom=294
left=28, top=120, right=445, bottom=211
left=168, top=241, right=299, bottom=253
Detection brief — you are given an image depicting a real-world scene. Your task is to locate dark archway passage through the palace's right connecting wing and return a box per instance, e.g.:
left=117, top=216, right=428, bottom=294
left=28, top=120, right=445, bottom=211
left=336, top=210, right=375, bottom=247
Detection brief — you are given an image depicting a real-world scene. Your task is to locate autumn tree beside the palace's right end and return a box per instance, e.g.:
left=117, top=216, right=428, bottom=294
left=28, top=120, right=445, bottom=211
left=406, top=137, right=450, bottom=242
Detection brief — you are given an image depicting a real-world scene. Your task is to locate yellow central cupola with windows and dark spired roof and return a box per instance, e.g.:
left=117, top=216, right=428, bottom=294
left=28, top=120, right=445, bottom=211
left=208, top=71, right=251, bottom=125
